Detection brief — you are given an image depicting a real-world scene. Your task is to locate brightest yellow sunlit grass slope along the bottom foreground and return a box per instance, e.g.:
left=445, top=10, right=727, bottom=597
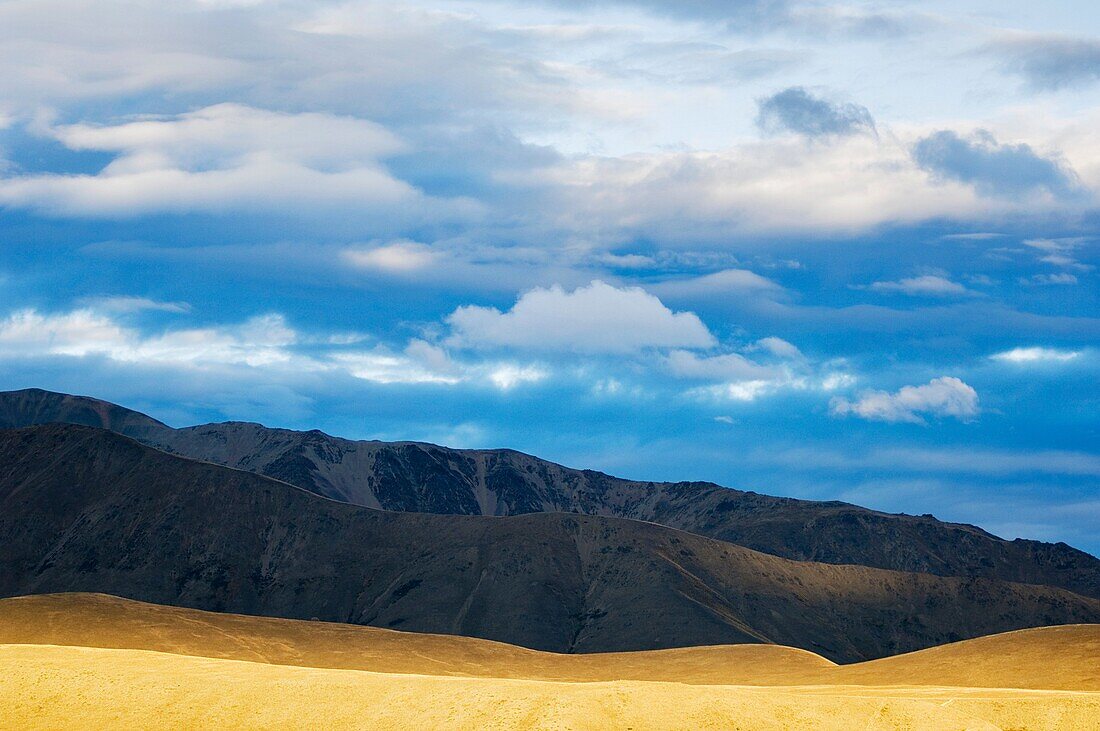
left=8, top=645, right=1100, bottom=731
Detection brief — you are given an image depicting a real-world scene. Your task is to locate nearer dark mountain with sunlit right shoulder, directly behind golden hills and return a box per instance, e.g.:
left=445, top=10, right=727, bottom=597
left=0, top=424, right=1100, bottom=661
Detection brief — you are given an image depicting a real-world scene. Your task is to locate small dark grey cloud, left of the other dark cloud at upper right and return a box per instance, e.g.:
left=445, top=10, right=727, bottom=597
left=757, top=87, right=875, bottom=137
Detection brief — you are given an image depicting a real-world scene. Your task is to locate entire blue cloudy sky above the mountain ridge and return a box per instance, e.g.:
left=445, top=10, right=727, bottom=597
left=0, top=0, right=1100, bottom=547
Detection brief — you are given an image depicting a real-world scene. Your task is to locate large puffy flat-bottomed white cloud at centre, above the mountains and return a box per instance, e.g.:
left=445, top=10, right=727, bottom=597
left=447, top=280, right=716, bottom=353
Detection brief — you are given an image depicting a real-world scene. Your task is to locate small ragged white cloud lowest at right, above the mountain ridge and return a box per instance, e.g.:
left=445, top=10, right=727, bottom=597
left=829, top=376, right=979, bottom=424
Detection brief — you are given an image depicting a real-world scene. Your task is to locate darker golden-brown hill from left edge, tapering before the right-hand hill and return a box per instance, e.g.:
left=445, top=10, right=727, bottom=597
left=0, top=594, right=835, bottom=684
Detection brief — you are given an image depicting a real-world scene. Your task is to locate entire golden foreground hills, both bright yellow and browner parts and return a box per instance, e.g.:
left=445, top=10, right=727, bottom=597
left=0, top=594, right=1100, bottom=730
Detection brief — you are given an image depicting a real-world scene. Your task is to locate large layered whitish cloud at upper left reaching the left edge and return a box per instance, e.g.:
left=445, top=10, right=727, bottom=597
left=0, top=103, right=448, bottom=218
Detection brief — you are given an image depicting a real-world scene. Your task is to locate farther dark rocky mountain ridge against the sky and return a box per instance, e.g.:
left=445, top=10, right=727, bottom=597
left=0, top=389, right=1100, bottom=597
